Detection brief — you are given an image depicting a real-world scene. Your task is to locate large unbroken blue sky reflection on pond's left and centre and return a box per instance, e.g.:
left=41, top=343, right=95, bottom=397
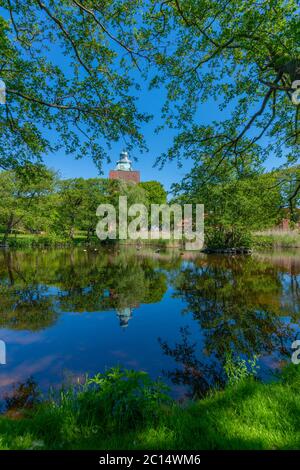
left=0, top=289, right=202, bottom=393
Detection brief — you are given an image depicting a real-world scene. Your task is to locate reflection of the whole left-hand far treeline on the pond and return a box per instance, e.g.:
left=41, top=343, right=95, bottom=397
left=0, top=246, right=173, bottom=331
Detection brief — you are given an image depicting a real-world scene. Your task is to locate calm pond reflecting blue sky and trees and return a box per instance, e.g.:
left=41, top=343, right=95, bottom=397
left=0, top=246, right=300, bottom=399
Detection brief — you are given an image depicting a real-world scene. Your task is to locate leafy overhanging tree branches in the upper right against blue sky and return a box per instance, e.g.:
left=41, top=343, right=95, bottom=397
left=148, top=0, right=300, bottom=173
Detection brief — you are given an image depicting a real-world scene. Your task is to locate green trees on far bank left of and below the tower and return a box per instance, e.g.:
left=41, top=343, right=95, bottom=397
left=0, top=164, right=167, bottom=243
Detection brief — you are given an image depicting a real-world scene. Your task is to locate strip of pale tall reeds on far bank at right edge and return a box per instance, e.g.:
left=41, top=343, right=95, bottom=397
left=253, top=230, right=300, bottom=248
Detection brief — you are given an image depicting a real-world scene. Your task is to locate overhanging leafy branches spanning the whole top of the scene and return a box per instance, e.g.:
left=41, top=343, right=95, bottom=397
left=0, top=0, right=300, bottom=193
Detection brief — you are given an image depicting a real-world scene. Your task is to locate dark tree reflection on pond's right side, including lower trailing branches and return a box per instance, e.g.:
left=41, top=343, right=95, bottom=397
left=161, top=257, right=299, bottom=394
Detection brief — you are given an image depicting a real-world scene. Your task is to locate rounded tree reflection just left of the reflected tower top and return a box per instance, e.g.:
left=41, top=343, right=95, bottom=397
left=54, top=253, right=167, bottom=320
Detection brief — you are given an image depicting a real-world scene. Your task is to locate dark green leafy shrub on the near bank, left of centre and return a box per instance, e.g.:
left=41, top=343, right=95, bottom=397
left=35, top=367, right=170, bottom=442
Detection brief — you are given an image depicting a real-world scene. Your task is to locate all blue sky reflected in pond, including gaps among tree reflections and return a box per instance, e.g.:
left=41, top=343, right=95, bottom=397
left=0, top=250, right=300, bottom=396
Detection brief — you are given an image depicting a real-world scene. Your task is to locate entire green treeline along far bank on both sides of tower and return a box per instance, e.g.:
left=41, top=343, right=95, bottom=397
left=0, top=164, right=300, bottom=247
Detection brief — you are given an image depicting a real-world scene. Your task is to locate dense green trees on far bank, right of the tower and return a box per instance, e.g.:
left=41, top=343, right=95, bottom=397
left=173, top=156, right=299, bottom=248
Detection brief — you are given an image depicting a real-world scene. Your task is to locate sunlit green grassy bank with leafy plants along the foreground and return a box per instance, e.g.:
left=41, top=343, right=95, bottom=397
left=0, top=366, right=300, bottom=450
